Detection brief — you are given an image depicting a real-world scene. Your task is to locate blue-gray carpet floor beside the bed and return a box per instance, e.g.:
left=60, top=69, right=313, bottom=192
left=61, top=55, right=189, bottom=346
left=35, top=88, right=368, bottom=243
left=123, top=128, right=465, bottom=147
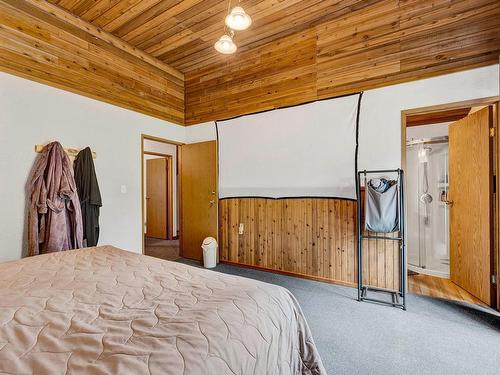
left=180, top=259, right=500, bottom=375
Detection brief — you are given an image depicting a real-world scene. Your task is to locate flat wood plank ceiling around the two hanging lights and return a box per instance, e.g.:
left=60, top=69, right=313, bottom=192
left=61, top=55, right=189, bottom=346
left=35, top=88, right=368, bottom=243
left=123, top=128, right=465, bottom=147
left=47, top=0, right=356, bottom=72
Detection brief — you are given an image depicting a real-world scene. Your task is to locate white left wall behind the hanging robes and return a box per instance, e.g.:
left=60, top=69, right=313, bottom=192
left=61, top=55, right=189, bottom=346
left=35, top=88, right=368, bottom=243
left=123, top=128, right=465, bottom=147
left=0, top=73, right=185, bottom=261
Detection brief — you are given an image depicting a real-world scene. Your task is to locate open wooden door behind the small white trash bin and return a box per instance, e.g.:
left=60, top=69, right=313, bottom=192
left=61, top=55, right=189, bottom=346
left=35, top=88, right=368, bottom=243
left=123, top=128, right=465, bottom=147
left=180, top=141, right=218, bottom=260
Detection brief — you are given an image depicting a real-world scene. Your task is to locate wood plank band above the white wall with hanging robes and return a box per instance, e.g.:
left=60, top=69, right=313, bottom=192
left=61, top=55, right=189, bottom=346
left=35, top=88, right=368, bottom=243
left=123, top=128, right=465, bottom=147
left=0, top=0, right=184, bottom=124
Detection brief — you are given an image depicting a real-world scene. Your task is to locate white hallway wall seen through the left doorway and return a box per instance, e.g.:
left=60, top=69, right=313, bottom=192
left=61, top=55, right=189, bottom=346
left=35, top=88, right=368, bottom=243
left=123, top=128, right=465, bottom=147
left=144, top=139, right=179, bottom=236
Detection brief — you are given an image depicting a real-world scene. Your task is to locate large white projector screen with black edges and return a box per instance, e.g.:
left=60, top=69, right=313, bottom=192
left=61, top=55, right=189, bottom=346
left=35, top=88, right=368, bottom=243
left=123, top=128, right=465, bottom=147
left=216, top=94, right=360, bottom=199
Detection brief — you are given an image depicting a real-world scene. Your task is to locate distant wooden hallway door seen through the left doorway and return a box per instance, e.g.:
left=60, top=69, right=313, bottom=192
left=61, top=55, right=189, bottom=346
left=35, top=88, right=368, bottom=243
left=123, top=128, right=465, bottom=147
left=146, top=158, right=168, bottom=239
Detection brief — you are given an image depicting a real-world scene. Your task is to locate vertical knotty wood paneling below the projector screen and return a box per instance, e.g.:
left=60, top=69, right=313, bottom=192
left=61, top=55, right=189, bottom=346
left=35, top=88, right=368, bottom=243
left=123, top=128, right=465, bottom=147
left=219, top=198, right=399, bottom=289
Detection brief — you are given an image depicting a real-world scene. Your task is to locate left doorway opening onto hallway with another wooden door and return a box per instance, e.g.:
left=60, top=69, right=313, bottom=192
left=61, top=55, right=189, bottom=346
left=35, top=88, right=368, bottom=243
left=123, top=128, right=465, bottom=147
left=141, top=135, right=180, bottom=260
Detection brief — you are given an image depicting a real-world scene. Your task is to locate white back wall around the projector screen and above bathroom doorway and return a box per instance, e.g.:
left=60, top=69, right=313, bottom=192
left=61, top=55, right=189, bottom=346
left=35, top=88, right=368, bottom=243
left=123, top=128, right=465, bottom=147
left=186, top=65, right=499, bottom=169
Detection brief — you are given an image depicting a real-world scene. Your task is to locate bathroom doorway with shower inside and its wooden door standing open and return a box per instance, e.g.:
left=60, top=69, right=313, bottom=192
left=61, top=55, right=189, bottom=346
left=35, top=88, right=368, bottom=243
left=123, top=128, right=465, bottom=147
left=402, top=97, right=499, bottom=308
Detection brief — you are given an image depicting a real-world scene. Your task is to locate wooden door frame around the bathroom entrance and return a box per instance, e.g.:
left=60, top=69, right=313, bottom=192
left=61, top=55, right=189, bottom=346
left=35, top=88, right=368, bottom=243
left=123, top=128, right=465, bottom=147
left=401, top=96, right=500, bottom=310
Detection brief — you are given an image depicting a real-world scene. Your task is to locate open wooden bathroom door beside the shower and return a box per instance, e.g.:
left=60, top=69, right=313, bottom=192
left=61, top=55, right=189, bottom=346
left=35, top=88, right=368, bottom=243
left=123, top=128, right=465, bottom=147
left=448, top=107, right=493, bottom=305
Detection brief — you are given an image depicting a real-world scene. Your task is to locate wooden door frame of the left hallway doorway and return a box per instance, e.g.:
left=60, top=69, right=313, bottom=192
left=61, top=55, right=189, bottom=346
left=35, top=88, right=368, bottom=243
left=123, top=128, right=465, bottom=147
left=140, top=133, right=184, bottom=254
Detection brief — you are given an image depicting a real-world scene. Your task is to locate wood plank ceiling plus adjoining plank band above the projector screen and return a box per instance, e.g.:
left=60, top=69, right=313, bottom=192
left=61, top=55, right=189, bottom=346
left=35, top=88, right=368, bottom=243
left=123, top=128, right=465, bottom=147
left=0, top=0, right=500, bottom=124
